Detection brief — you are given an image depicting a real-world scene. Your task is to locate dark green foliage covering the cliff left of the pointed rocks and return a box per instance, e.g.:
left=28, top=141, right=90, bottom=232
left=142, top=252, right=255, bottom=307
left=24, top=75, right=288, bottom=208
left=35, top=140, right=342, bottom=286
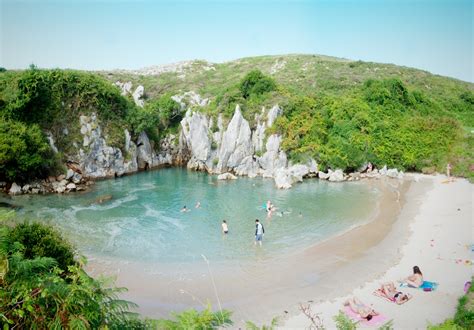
left=0, top=66, right=133, bottom=182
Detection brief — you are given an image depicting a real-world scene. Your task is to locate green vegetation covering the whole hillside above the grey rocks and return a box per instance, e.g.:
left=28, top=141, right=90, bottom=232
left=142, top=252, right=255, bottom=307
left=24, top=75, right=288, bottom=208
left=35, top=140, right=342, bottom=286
left=0, top=55, right=474, bottom=180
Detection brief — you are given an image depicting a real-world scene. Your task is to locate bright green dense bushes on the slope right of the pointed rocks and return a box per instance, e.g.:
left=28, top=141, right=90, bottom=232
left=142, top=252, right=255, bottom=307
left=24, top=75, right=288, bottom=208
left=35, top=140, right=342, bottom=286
left=274, top=79, right=462, bottom=171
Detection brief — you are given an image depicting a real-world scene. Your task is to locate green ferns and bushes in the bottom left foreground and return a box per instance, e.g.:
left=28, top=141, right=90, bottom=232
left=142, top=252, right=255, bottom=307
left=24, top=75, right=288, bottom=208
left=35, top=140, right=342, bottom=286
left=0, top=220, right=141, bottom=329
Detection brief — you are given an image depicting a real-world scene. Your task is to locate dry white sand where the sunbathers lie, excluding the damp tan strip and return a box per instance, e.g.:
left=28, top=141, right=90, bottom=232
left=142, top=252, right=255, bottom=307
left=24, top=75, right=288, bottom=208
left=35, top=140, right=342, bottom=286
left=281, top=175, right=474, bottom=329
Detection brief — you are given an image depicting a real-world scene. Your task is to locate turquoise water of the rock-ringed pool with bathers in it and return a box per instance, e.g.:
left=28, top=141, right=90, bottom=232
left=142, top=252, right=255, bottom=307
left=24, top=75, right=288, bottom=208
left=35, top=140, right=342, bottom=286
left=7, top=168, right=377, bottom=263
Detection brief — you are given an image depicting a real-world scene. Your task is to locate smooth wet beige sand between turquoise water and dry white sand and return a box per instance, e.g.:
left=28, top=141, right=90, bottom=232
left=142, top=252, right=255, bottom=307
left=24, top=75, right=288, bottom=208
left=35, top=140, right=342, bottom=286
left=88, top=178, right=418, bottom=327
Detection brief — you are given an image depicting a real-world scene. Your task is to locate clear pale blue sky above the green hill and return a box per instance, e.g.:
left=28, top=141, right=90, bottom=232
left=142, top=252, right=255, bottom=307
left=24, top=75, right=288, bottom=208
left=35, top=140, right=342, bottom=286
left=0, top=0, right=474, bottom=82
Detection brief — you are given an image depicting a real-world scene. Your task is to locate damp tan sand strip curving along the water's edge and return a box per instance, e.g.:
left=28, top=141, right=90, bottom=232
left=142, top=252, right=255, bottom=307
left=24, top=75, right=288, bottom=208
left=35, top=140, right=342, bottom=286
left=87, top=178, right=410, bottom=326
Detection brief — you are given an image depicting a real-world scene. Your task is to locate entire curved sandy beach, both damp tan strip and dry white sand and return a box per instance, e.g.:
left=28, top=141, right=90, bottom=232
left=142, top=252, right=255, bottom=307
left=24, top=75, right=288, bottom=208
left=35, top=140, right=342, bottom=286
left=88, top=174, right=473, bottom=329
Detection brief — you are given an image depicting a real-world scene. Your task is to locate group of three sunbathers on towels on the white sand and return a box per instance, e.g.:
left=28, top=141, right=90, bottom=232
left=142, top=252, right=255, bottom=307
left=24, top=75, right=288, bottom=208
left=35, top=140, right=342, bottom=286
left=344, top=266, right=423, bottom=321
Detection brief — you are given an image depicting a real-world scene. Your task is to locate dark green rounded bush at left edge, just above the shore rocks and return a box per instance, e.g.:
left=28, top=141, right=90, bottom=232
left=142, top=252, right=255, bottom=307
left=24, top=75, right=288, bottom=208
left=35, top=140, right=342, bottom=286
left=0, top=119, right=54, bottom=182
